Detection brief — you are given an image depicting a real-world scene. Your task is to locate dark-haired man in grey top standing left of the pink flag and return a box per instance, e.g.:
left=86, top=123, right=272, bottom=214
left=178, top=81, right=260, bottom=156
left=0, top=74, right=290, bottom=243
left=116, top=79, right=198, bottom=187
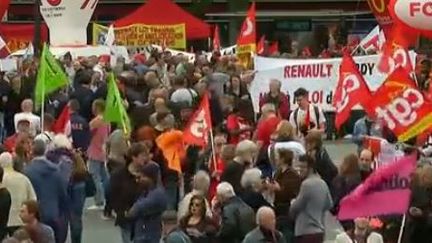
left=290, top=155, right=333, bottom=243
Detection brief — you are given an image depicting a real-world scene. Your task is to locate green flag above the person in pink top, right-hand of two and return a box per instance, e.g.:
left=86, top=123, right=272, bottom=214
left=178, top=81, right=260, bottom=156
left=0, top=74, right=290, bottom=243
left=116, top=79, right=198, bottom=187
left=104, top=73, right=131, bottom=134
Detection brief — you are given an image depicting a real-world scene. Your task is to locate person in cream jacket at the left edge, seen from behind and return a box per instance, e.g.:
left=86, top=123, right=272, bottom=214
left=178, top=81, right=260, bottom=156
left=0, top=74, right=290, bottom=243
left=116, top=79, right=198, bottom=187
left=0, top=152, right=36, bottom=235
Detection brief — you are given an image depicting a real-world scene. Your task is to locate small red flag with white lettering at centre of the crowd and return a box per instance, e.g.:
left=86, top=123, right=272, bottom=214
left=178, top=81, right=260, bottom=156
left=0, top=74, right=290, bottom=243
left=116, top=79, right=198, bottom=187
left=183, top=93, right=212, bottom=147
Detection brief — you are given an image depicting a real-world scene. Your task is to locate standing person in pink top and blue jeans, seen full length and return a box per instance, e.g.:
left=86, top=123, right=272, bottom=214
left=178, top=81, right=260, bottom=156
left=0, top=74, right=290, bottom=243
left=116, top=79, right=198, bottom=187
left=87, top=100, right=110, bottom=210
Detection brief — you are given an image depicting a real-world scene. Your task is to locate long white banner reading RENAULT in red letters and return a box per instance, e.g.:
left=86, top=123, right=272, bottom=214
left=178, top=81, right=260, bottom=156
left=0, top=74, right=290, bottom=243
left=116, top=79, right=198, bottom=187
left=250, top=51, right=417, bottom=112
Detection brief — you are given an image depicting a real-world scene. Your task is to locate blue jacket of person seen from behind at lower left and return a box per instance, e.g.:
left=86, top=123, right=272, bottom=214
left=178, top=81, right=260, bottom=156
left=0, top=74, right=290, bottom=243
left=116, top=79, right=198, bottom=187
left=24, top=157, right=68, bottom=222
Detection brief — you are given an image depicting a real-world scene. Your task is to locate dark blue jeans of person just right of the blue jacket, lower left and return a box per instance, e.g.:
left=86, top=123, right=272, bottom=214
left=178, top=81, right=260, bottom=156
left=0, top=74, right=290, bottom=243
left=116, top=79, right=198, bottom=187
left=69, top=182, right=86, bottom=243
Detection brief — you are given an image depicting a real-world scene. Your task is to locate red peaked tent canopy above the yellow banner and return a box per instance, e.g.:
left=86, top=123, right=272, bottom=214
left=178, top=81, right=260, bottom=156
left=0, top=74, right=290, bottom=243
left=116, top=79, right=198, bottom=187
left=114, top=0, right=210, bottom=39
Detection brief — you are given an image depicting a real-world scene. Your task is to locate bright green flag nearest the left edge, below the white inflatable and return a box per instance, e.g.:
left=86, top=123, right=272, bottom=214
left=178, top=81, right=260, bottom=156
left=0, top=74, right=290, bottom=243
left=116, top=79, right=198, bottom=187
left=35, top=44, right=69, bottom=107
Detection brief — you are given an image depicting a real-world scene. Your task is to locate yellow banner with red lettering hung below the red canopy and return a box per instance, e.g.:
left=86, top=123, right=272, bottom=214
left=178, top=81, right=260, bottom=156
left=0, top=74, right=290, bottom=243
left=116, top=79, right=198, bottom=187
left=93, top=23, right=186, bottom=49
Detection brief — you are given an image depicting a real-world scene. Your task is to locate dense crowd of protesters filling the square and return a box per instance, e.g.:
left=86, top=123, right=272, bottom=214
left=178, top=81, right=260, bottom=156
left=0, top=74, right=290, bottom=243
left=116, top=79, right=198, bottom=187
left=0, top=47, right=432, bottom=243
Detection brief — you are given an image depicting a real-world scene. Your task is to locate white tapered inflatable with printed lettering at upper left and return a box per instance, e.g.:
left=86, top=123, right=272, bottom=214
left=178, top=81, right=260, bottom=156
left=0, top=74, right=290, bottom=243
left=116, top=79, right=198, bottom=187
left=40, top=0, right=98, bottom=46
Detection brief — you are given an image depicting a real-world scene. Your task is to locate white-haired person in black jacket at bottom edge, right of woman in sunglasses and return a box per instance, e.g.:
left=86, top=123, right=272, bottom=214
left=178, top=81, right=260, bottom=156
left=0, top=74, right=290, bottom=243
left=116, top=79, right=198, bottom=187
left=214, top=182, right=255, bottom=243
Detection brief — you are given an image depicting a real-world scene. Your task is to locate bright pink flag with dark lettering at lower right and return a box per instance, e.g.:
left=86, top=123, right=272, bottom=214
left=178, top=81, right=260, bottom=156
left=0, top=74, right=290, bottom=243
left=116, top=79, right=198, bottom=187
left=338, top=156, right=416, bottom=220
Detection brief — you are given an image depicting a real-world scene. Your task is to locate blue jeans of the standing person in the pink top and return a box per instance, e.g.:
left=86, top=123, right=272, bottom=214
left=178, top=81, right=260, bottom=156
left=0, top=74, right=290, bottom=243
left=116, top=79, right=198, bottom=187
left=88, top=160, right=108, bottom=206
